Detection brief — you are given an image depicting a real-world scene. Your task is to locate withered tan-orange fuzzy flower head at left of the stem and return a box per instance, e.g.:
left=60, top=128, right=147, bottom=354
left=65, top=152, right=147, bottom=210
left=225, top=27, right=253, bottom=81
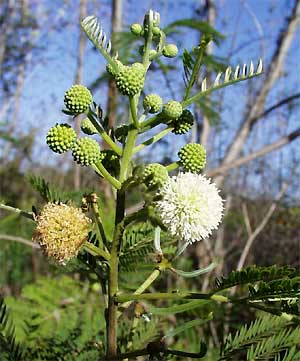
left=33, top=203, right=92, bottom=263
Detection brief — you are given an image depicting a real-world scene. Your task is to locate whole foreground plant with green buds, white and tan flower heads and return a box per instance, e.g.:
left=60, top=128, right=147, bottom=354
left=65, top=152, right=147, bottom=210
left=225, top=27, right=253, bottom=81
left=2, top=10, right=300, bottom=360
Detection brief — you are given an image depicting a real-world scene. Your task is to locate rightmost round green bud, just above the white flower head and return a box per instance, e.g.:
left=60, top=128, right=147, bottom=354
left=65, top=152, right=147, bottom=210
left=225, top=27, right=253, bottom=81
left=178, top=143, right=206, bottom=173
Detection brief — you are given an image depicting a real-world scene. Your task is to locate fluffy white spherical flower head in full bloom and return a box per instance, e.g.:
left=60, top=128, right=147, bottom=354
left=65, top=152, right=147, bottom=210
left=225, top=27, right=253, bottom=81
left=156, top=172, right=223, bottom=244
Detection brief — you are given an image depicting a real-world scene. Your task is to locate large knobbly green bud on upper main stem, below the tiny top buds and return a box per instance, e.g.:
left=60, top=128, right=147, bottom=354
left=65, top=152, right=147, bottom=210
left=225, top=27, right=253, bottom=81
left=116, top=63, right=145, bottom=96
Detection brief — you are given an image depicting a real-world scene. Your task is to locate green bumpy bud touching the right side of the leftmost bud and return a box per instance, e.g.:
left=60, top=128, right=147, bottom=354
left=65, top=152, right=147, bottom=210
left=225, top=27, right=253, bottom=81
left=72, top=137, right=100, bottom=165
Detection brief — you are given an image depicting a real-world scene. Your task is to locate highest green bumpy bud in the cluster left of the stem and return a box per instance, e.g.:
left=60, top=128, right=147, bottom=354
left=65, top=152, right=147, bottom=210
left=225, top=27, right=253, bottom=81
left=64, top=84, right=93, bottom=114
